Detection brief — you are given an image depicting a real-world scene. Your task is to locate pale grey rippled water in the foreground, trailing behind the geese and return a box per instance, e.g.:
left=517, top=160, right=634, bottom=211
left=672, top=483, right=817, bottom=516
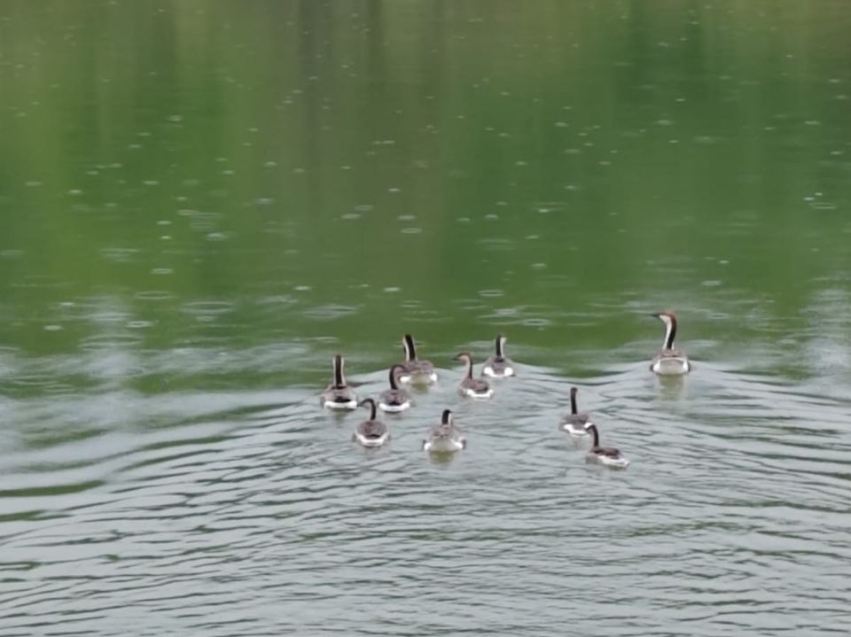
left=0, top=362, right=851, bottom=636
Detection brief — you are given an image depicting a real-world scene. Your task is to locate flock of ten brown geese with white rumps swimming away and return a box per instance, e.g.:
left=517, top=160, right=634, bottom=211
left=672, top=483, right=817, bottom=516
left=320, top=310, right=692, bottom=469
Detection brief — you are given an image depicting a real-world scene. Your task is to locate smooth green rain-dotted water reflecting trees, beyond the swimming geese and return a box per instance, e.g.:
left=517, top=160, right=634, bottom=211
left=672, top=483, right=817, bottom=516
left=0, top=0, right=851, bottom=378
